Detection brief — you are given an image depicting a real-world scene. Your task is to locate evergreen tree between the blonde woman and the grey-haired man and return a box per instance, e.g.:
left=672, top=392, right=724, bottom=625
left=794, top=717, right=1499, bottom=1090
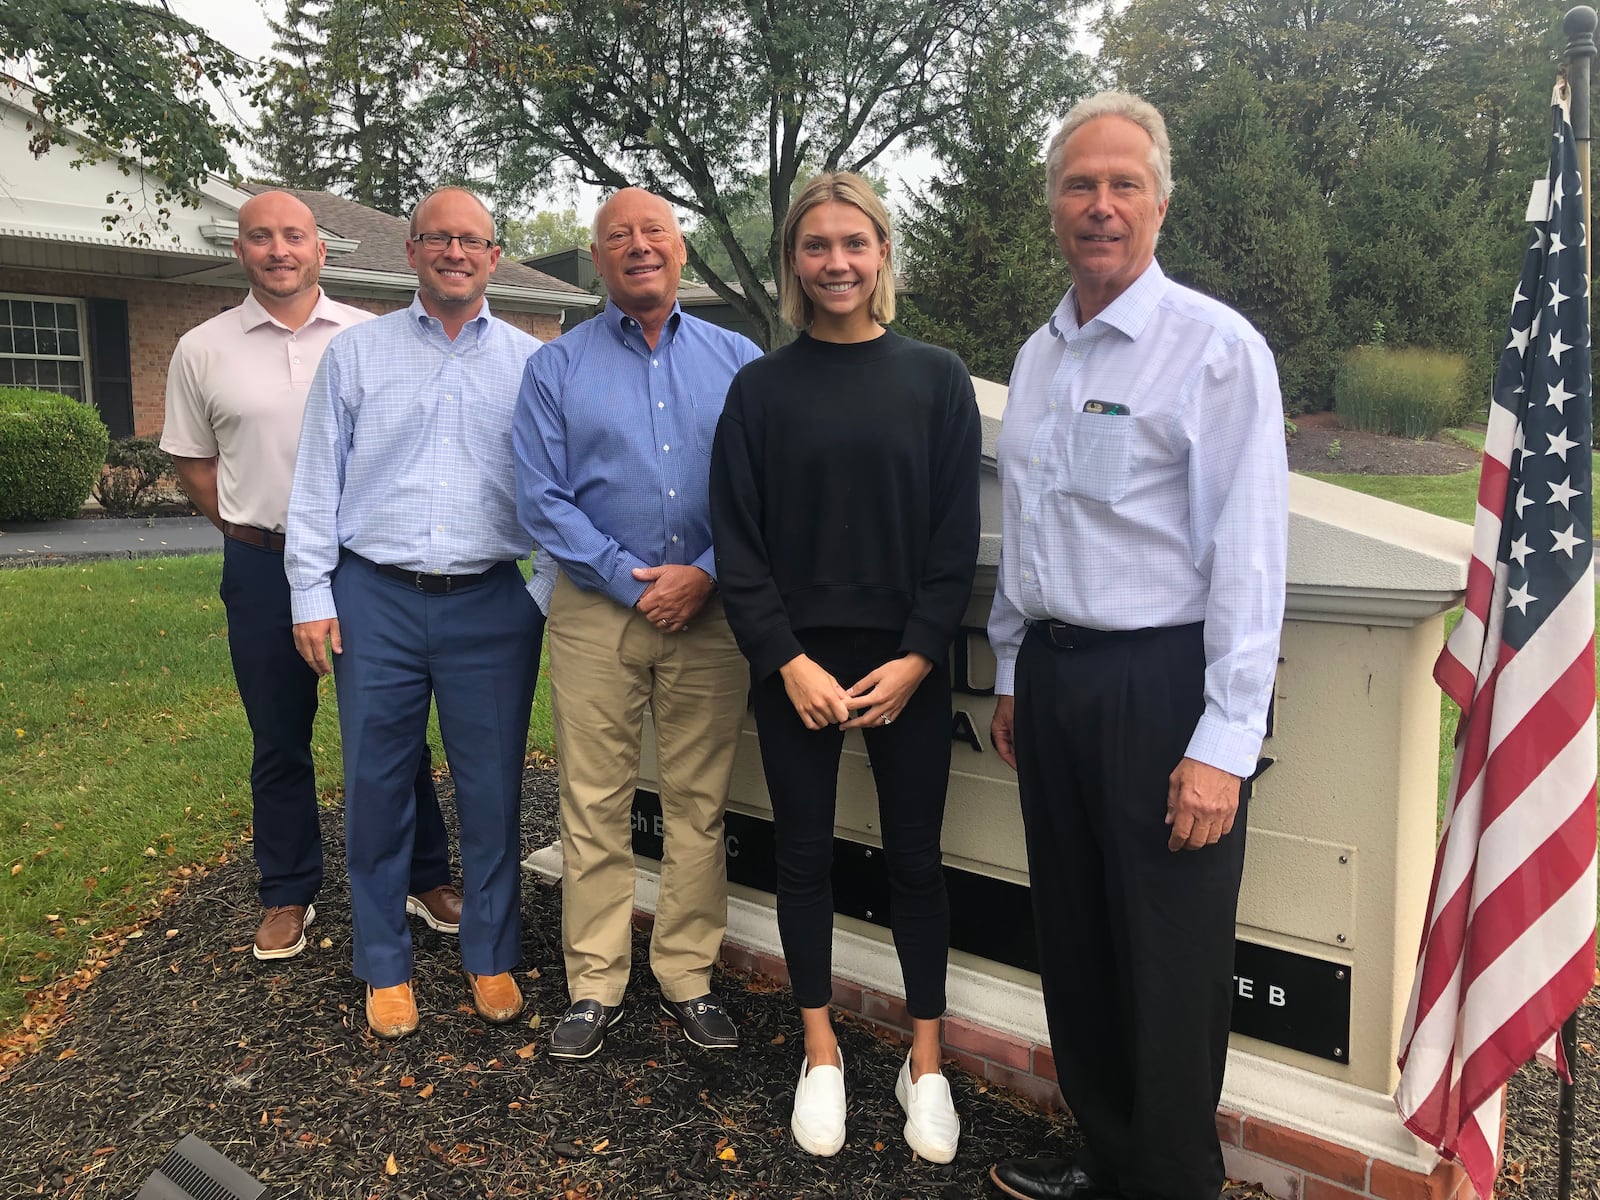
left=896, top=21, right=1082, bottom=381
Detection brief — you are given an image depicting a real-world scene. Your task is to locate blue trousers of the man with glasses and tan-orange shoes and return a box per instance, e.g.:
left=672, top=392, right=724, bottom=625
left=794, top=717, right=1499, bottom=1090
left=333, top=554, right=544, bottom=987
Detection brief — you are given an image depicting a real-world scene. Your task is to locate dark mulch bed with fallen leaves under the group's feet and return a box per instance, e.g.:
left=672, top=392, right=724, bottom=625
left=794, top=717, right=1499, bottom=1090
left=0, top=770, right=1600, bottom=1200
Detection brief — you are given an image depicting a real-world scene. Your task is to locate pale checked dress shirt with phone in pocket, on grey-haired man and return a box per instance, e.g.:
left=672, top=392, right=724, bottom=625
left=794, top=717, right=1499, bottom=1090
left=989, top=262, right=1288, bottom=778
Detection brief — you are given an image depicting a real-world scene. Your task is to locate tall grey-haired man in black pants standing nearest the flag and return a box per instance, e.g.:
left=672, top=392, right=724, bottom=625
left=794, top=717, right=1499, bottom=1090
left=989, top=93, right=1288, bottom=1200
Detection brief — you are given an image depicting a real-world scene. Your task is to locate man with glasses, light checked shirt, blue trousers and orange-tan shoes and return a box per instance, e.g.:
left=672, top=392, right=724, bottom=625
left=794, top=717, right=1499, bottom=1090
left=286, top=187, right=556, bottom=1038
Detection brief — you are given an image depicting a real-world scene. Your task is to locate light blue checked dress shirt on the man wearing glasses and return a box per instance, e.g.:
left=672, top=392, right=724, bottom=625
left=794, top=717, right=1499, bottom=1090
left=285, top=298, right=554, bottom=622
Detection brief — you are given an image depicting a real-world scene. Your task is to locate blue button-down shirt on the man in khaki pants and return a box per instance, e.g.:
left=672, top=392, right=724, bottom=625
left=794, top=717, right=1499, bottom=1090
left=512, top=302, right=762, bottom=610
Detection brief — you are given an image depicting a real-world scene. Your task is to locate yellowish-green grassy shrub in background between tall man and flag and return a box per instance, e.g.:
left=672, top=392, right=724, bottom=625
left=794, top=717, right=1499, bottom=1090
left=1333, top=346, right=1467, bottom=437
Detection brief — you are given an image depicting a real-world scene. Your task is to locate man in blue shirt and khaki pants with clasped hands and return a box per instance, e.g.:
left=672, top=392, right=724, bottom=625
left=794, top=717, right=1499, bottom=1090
left=514, top=187, right=760, bottom=1059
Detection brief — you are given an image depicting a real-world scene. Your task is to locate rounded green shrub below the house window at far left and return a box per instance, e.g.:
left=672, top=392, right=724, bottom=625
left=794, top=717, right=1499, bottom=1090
left=0, top=387, right=110, bottom=522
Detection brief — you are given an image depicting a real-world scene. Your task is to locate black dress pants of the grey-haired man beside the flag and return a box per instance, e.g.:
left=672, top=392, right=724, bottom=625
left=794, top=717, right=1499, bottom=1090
left=1016, top=626, right=1246, bottom=1200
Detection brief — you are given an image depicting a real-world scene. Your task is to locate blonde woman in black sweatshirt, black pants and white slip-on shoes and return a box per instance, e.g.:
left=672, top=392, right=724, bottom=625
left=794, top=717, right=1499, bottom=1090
left=710, top=171, right=981, bottom=1163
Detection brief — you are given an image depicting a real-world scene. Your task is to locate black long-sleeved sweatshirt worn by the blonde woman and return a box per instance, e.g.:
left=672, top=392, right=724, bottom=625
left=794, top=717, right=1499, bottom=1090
left=710, top=331, right=982, bottom=678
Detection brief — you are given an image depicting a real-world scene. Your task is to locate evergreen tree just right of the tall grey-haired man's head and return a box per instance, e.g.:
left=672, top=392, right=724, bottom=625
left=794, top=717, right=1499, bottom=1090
left=1157, top=67, right=1333, bottom=413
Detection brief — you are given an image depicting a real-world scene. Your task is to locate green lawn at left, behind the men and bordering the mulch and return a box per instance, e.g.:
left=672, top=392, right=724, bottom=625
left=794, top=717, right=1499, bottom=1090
left=0, top=555, right=552, bottom=1029
